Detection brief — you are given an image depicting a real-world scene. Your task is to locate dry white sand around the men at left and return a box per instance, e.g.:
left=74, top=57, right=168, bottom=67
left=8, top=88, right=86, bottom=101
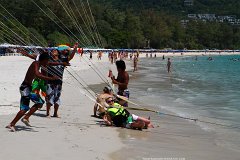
left=0, top=56, right=122, bottom=160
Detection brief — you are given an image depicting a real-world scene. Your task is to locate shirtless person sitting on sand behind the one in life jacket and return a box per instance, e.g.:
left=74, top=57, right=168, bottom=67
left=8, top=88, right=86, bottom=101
left=93, top=86, right=113, bottom=118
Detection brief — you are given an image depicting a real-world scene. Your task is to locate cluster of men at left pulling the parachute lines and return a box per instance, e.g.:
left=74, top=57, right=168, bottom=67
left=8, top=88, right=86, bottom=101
left=6, top=43, right=78, bottom=131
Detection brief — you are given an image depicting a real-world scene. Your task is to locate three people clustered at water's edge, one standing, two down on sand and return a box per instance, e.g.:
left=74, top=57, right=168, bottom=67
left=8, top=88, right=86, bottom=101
left=93, top=60, right=153, bottom=130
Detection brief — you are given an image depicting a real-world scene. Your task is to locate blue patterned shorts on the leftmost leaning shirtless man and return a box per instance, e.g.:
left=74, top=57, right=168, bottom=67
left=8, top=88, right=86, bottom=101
left=20, top=83, right=44, bottom=111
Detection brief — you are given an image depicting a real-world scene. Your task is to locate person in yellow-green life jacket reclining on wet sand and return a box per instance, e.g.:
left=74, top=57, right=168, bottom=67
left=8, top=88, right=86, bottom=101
left=103, top=97, right=154, bottom=130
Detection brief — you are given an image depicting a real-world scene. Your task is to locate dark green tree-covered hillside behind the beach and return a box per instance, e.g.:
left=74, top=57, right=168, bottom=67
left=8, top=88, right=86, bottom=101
left=0, top=0, right=240, bottom=49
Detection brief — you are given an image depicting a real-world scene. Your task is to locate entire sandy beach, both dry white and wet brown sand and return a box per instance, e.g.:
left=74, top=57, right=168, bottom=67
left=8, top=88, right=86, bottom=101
left=0, top=53, right=240, bottom=160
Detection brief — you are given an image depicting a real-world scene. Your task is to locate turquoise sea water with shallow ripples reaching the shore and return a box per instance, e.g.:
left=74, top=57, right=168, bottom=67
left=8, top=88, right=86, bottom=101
left=129, top=55, right=240, bottom=149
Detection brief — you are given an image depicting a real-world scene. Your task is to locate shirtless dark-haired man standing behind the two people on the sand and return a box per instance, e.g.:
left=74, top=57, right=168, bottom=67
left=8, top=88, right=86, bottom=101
left=111, top=60, right=130, bottom=107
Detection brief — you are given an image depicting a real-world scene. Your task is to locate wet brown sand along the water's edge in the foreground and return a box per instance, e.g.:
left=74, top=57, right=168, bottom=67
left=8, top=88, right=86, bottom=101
left=111, top=56, right=240, bottom=160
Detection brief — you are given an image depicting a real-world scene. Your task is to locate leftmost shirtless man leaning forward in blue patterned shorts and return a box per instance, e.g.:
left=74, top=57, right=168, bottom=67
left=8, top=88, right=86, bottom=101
left=6, top=53, right=58, bottom=132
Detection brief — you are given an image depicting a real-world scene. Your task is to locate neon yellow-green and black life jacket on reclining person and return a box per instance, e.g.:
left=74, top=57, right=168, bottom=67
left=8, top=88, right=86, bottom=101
left=107, top=103, right=130, bottom=127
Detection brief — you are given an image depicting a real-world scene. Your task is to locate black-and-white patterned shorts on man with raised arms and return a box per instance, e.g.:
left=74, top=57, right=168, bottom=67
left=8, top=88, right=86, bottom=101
left=47, top=84, right=62, bottom=105
